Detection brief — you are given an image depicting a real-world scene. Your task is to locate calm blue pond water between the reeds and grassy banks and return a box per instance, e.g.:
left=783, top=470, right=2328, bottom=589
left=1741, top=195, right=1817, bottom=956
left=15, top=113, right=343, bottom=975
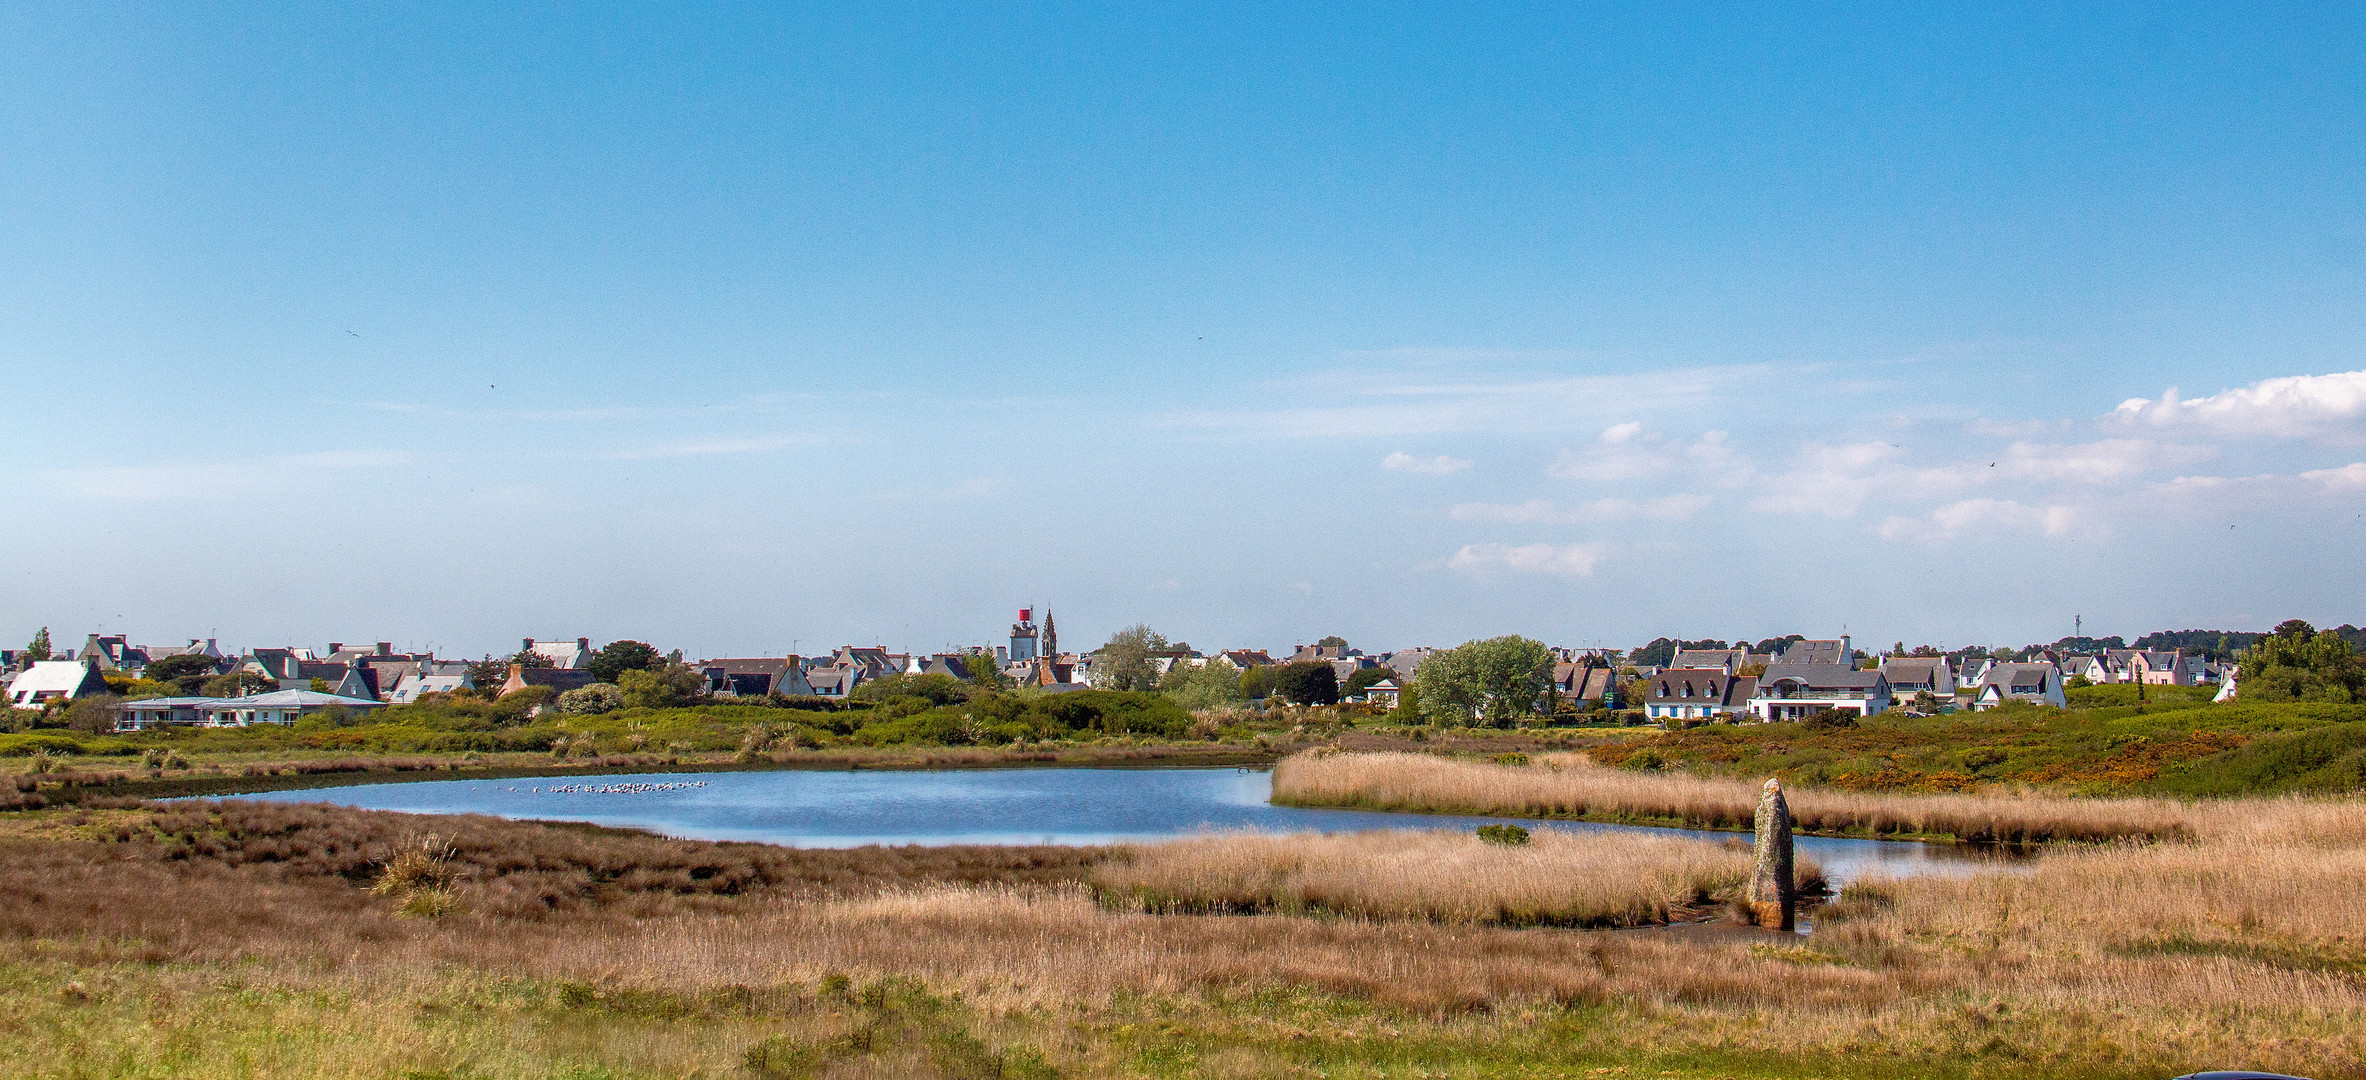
left=222, top=767, right=1995, bottom=881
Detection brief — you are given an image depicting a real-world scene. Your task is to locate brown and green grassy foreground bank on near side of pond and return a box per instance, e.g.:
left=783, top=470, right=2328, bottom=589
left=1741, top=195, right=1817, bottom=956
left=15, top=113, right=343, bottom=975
left=0, top=801, right=2366, bottom=1080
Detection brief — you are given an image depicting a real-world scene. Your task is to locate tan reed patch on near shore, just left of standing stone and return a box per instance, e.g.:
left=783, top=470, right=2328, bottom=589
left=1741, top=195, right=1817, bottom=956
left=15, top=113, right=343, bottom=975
left=1093, top=829, right=1822, bottom=928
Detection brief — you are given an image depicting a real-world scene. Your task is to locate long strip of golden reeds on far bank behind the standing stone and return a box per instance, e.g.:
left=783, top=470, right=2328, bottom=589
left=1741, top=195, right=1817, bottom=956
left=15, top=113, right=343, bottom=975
left=1273, top=753, right=2193, bottom=843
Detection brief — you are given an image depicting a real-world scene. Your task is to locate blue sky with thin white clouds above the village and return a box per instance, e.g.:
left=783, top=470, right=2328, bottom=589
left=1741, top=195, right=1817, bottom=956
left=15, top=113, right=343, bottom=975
left=0, top=5, right=2366, bottom=654
